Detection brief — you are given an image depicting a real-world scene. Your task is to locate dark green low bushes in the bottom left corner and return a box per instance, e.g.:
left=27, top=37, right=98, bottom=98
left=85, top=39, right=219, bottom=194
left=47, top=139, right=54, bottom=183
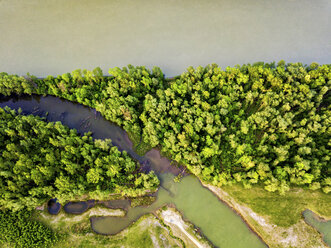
left=0, top=211, right=58, bottom=248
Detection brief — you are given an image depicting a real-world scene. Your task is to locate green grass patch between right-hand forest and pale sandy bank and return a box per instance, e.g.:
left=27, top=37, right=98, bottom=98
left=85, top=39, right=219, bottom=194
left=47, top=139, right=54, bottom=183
left=222, top=184, right=331, bottom=227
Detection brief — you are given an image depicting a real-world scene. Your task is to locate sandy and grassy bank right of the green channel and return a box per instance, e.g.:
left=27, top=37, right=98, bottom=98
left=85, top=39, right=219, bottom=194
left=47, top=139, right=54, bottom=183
left=203, top=184, right=331, bottom=248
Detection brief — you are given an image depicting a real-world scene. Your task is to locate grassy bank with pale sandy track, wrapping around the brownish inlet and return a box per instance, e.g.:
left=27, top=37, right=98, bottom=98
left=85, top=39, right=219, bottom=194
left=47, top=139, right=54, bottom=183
left=34, top=202, right=212, bottom=248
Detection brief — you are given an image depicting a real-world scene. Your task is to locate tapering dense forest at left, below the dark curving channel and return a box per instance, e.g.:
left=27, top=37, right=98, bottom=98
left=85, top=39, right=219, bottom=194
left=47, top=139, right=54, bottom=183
left=0, top=107, right=159, bottom=211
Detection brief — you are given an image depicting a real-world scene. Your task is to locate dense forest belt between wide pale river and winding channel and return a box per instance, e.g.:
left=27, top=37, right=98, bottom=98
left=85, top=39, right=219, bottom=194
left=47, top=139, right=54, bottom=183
left=0, top=61, right=331, bottom=193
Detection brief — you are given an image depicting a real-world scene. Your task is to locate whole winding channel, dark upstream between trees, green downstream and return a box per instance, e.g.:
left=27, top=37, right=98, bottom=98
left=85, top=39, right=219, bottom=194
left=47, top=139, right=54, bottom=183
left=0, top=96, right=266, bottom=248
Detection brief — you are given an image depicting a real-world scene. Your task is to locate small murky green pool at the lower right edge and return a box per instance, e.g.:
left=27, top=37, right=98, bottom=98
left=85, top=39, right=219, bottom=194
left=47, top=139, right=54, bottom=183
left=303, top=209, right=331, bottom=247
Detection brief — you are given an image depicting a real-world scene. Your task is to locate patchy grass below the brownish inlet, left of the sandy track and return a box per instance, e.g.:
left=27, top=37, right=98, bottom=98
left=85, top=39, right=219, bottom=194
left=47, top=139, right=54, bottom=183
left=34, top=207, right=182, bottom=248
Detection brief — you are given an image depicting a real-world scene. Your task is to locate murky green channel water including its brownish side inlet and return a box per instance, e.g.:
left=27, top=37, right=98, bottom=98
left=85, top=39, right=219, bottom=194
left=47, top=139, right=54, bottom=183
left=91, top=174, right=266, bottom=248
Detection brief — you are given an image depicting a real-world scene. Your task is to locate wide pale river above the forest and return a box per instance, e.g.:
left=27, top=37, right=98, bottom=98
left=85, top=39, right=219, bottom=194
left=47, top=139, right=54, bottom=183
left=0, top=0, right=331, bottom=77
